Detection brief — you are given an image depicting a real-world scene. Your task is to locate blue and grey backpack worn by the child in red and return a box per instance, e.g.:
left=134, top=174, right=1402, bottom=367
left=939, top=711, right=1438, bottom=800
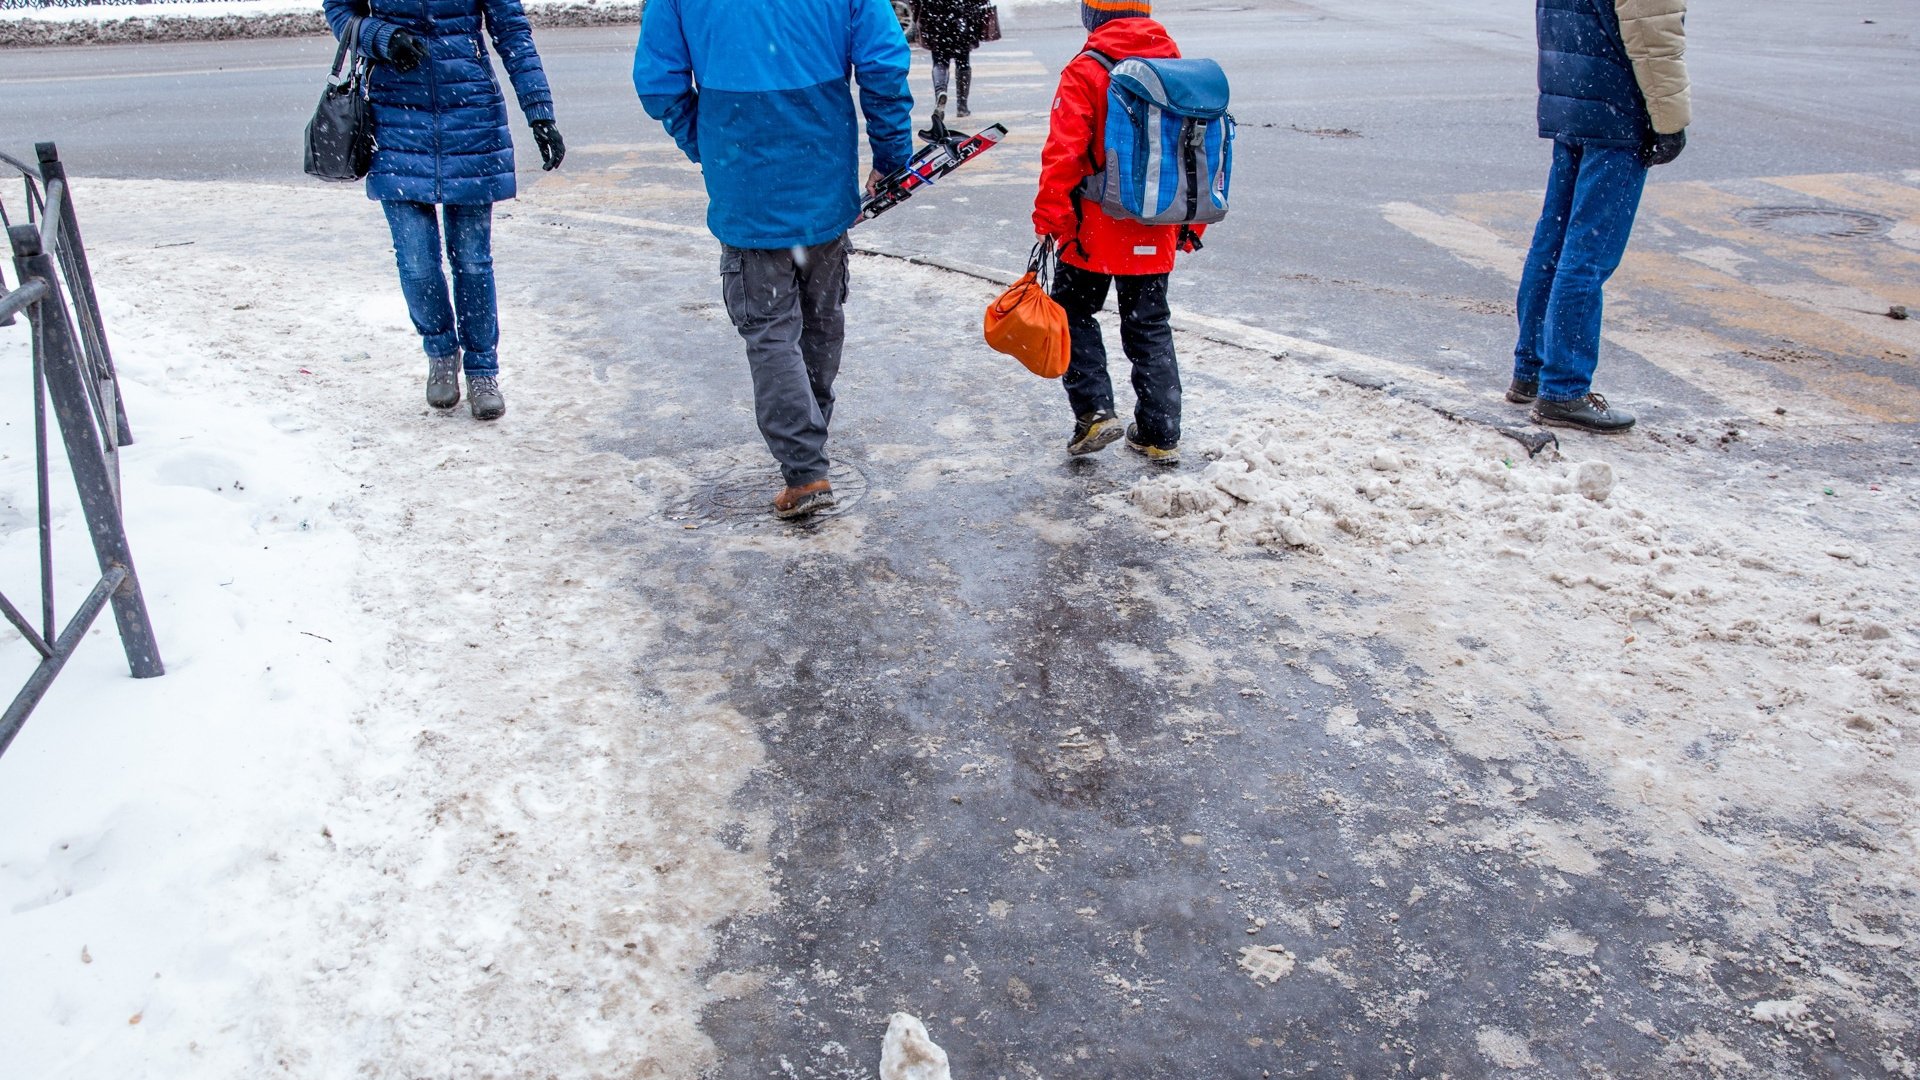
left=1079, top=48, right=1233, bottom=225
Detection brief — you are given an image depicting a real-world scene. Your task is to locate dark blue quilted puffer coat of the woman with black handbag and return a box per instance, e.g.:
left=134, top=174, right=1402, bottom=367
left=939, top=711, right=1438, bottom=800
left=324, top=0, right=553, bottom=204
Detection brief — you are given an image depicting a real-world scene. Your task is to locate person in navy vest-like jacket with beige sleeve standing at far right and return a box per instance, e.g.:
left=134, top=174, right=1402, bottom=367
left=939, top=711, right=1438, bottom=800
left=1507, top=0, right=1693, bottom=432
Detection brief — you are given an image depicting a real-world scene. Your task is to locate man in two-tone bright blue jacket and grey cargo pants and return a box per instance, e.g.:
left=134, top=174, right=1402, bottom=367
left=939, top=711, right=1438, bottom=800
left=634, top=0, right=914, bottom=517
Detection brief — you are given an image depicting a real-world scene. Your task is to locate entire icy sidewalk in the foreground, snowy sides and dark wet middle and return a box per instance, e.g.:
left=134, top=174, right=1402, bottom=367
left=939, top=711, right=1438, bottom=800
left=0, top=177, right=1920, bottom=1078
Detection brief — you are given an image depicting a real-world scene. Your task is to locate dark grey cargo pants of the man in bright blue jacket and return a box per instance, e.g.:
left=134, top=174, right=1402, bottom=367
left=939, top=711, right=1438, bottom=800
left=720, top=233, right=847, bottom=486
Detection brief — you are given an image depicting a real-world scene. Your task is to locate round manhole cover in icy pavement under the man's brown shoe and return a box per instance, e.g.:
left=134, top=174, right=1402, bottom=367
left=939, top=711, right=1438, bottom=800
left=634, top=446, right=868, bottom=532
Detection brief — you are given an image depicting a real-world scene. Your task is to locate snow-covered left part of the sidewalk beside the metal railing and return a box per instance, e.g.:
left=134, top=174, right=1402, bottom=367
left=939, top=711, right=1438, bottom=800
left=0, top=181, right=764, bottom=1076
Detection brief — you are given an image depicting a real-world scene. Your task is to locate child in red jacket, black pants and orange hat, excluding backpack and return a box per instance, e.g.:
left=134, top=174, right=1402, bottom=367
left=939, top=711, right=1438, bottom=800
left=1033, top=0, right=1204, bottom=465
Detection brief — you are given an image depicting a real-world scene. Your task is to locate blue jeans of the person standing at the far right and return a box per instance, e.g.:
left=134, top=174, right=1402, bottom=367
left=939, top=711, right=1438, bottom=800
left=1513, top=140, right=1647, bottom=402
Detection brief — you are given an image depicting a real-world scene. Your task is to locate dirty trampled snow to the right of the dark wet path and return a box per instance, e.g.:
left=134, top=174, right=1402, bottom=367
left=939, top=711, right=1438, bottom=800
left=1096, top=361, right=1920, bottom=907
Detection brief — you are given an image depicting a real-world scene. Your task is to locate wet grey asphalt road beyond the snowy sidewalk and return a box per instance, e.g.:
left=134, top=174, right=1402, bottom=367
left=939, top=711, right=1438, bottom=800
left=0, top=0, right=1920, bottom=443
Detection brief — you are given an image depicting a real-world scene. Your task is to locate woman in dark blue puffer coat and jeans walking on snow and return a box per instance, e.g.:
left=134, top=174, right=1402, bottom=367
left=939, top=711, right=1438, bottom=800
left=324, top=0, right=566, bottom=421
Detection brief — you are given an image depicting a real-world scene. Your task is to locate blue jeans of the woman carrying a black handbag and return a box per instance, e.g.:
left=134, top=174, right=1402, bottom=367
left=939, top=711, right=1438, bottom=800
left=380, top=202, right=499, bottom=375
